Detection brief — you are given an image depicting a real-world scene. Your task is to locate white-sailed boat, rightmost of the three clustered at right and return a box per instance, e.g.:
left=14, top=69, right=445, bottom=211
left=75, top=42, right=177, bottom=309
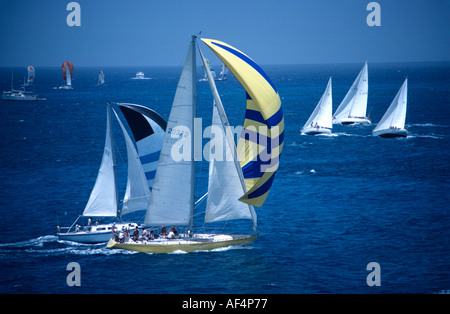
left=372, top=78, right=408, bottom=137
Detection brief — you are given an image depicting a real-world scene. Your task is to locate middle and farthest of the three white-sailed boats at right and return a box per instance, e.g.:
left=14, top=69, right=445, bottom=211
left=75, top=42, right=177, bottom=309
left=333, top=61, right=371, bottom=125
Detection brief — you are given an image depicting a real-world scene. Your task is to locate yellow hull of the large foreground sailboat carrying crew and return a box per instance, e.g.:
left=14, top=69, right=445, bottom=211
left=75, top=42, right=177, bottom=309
left=106, top=234, right=258, bottom=253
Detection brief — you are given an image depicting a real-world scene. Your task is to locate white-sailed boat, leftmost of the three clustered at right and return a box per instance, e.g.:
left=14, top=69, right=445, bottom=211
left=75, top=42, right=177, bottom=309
left=301, top=77, right=333, bottom=135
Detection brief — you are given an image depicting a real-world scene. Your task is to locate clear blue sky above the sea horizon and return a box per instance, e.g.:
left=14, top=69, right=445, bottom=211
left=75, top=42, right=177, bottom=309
left=0, top=0, right=450, bottom=67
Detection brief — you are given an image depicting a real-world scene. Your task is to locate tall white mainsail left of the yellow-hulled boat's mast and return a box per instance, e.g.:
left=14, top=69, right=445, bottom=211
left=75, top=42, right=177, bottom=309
left=145, top=41, right=196, bottom=226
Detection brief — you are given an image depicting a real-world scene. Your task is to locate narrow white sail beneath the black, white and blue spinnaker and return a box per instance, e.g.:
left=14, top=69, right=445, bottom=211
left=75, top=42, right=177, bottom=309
left=114, top=111, right=150, bottom=215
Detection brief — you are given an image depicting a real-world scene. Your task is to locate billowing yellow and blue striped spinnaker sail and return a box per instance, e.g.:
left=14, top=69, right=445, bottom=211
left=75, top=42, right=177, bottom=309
left=202, top=38, right=284, bottom=206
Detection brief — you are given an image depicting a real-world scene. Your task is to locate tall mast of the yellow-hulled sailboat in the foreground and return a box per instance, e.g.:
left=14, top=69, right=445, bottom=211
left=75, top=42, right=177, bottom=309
left=189, top=35, right=197, bottom=233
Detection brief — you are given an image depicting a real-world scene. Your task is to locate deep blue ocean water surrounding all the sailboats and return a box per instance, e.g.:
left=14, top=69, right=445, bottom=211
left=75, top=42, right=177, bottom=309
left=0, top=63, right=450, bottom=294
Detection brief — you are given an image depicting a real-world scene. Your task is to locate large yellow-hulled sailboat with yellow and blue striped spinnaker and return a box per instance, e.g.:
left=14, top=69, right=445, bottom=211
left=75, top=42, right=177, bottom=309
left=107, top=36, right=284, bottom=253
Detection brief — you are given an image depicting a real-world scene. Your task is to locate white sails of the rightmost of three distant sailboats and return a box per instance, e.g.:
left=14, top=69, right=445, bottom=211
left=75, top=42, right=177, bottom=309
left=374, top=79, right=408, bottom=131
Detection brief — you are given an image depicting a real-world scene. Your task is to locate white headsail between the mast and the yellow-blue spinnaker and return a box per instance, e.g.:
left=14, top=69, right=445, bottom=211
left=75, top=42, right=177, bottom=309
left=199, top=44, right=257, bottom=231
